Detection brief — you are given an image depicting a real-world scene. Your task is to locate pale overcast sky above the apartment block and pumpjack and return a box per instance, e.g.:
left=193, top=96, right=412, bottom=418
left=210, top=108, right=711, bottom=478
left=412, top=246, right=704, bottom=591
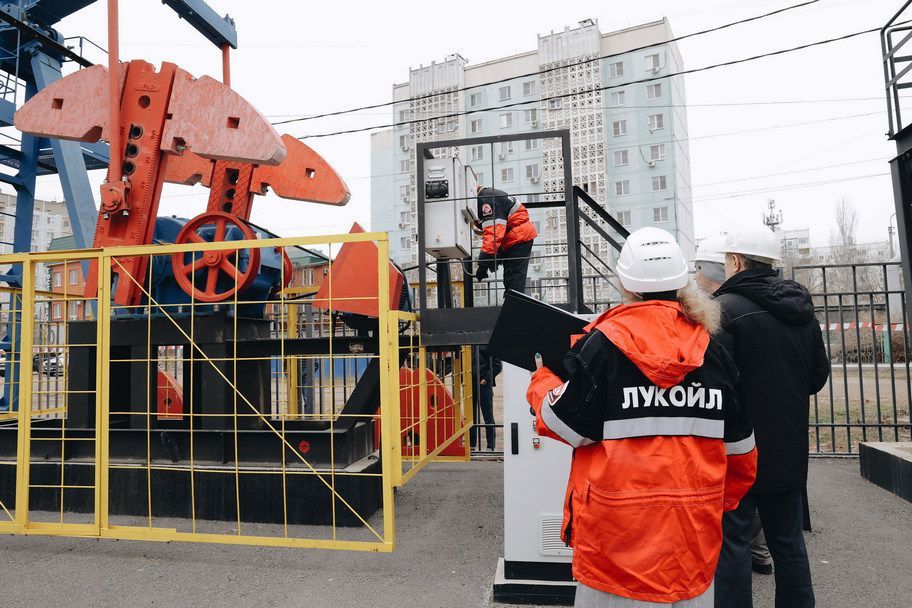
left=30, top=0, right=901, bottom=244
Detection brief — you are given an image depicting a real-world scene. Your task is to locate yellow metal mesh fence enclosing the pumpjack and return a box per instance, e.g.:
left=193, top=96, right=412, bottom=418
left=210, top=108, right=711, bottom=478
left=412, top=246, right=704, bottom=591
left=0, top=233, right=473, bottom=552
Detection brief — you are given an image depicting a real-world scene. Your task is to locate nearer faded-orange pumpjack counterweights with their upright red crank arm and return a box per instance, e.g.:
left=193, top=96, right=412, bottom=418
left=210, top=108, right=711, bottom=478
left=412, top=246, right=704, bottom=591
left=15, top=60, right=286, bottom=305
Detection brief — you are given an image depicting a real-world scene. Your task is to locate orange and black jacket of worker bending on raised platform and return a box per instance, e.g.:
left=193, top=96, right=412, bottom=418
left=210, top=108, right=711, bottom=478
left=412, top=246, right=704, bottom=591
left=478, top=188, right=538, bottom=256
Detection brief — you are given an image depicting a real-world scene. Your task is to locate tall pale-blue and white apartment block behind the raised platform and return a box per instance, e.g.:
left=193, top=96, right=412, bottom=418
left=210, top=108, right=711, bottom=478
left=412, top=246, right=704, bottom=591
left=371, top=19, right=694, bottom=302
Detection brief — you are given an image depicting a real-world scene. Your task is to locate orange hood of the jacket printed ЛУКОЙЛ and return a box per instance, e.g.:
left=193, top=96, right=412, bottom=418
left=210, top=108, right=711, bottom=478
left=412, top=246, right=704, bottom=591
left=586, top=300, right=709, bottom=388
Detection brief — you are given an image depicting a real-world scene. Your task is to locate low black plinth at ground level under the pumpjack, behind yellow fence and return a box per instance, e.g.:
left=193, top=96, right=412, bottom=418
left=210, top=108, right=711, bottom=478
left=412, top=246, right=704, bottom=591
left=0, top=455, right=382, bottom=526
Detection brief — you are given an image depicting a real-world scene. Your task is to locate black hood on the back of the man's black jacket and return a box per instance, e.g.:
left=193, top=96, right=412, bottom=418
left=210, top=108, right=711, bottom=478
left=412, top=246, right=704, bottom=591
left=716, top=269, right=814, bottom=325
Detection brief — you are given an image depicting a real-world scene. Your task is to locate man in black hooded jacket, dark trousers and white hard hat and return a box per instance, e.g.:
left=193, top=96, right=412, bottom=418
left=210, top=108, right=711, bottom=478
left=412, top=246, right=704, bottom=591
left=715, top=227, right=830, bottom=608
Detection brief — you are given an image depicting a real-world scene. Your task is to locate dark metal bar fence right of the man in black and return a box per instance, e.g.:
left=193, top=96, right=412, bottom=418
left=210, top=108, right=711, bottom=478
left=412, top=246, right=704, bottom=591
left=790, top=262, right=912, bottom=456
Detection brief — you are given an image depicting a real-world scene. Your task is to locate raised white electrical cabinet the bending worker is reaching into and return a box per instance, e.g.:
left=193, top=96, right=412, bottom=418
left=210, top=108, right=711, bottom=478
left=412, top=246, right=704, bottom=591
left=424, top=158, right=477, bottom=260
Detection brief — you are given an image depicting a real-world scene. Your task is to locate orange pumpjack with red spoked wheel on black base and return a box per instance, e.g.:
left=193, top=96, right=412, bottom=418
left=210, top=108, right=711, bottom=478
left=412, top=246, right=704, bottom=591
left=0, top=50, right=404, bottom=525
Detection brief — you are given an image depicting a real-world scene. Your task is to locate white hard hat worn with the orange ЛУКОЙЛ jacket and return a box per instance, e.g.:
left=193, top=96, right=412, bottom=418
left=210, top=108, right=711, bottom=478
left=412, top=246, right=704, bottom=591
left=615, top=226, right=688, bottom=293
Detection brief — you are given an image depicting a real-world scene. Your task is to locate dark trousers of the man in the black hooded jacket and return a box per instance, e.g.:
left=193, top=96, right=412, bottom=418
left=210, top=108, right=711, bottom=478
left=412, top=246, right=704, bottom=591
left=715, top=489, right=814, bottom=608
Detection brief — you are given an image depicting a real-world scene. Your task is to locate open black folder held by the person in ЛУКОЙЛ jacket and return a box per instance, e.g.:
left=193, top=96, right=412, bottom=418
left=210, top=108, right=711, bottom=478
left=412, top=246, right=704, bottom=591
left=488, top=289, right=589, bottom=380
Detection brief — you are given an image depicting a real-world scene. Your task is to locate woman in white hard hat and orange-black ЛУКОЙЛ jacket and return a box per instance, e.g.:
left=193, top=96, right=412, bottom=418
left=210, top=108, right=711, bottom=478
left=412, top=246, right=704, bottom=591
left=527, top=227, right=757, bottom=608
